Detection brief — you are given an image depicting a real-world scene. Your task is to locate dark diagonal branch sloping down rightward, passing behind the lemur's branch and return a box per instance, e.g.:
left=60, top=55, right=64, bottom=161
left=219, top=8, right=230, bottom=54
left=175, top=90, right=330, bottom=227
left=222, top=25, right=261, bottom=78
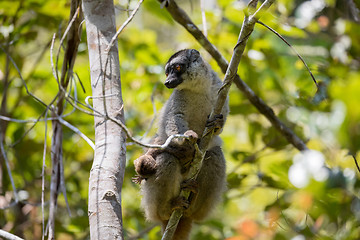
left=158, top=0, right=308, bottom=151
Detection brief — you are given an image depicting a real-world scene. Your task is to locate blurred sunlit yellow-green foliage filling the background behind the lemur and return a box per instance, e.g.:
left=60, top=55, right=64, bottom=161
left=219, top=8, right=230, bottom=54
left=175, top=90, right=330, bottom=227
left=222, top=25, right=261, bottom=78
left=0, top=0, right=360, bottom=240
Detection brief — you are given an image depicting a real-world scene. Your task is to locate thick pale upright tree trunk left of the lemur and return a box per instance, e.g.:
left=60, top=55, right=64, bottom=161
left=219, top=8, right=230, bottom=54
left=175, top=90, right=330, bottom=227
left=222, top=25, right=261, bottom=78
left=83, top=0, right=126, bottom=239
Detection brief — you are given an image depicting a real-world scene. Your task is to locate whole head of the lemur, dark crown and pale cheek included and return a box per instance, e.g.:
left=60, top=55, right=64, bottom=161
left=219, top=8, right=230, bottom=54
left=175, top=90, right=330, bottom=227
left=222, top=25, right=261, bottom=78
left=165, top=49, right=211, bottom=90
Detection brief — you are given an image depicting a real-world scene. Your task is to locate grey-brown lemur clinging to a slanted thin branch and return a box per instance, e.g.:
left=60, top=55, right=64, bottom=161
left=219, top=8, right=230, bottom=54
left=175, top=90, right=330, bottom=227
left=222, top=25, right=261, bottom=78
left=134, top=49, right=229, bottom=240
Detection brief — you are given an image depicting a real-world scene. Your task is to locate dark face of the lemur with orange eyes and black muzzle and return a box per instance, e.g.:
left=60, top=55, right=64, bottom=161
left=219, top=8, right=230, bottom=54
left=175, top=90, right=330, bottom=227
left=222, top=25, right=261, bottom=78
left=165, top=49, right=201, bottom=88
